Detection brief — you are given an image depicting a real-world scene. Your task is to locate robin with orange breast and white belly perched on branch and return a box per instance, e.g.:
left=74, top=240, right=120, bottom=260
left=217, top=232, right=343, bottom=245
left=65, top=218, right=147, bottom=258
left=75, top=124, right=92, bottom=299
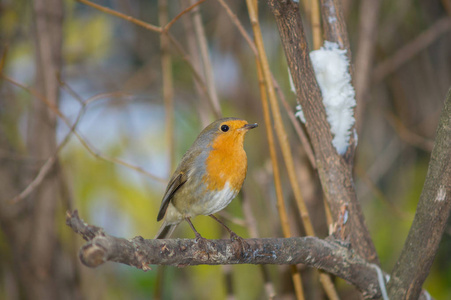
left=155, top=118, right=258, bottom=239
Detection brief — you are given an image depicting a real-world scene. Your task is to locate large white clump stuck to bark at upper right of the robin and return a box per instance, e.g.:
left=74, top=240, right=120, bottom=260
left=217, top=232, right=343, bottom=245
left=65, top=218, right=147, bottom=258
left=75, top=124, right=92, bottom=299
left=310, top=41, right=356, bottom=154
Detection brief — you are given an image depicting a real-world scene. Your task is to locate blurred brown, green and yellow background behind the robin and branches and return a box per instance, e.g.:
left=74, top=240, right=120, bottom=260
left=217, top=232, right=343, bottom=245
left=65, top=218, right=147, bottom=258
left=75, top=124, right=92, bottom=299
left=0, top=0, right=451, bottom=299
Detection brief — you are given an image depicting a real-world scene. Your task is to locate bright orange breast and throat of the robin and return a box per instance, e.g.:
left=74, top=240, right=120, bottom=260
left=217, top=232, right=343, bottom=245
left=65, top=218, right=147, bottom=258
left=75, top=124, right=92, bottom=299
left=203, top=131, right=247, bottom=191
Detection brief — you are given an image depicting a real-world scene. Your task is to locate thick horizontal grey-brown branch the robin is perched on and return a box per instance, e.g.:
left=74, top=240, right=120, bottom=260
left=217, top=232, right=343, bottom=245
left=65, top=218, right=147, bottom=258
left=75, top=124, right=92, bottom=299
left=66, top=211, right=381, bottom=299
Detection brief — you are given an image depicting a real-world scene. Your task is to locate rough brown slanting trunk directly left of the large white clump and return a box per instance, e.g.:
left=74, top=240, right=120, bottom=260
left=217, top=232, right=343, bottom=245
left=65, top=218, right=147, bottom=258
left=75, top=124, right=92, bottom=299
left=269, top=0, right=378, bottom=263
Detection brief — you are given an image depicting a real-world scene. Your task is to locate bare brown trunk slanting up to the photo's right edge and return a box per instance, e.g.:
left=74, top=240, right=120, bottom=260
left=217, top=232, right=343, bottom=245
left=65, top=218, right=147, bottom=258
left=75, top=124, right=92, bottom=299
left=388, top=90, right=451, bottom=299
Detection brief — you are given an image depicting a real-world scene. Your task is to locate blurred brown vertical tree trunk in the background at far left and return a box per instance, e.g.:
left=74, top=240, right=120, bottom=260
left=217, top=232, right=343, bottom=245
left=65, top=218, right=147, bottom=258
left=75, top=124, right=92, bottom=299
left=27, top=0, right=63, bottom=299
